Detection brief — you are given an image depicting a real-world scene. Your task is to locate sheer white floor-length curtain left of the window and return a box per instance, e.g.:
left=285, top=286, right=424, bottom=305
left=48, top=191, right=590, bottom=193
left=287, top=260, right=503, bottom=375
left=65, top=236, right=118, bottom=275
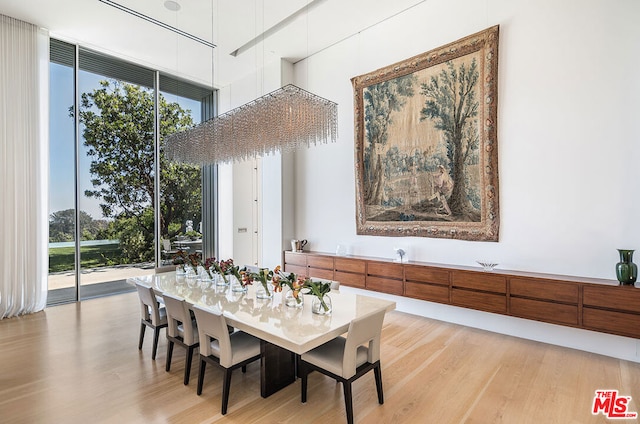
left=0, top=15, right=49, bottom=319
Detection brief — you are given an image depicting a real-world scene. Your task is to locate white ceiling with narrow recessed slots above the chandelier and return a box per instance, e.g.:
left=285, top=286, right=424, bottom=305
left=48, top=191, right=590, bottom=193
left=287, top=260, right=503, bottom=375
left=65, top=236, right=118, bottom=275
left=0, top=0, right=425, bottom=87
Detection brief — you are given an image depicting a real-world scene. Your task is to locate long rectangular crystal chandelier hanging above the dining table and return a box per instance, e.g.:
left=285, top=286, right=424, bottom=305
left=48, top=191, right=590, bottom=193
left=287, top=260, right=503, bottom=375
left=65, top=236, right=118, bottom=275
left=165, top=84, right=338, bottom=165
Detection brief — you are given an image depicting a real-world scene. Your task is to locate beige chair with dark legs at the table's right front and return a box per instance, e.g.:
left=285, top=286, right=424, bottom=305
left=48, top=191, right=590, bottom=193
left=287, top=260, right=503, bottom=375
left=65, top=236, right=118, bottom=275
left=300, top=310, right=385, bottom=424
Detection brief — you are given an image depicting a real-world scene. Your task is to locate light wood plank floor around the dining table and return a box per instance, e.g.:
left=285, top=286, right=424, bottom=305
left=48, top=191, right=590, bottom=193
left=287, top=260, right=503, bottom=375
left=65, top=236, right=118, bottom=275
left=0, top=293, right=640, bottom=424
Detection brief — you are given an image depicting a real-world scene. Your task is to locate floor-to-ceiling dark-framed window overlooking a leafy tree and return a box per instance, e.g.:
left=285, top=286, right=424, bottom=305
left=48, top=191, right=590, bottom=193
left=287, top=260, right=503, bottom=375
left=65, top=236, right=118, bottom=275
left=49, top=40, right=212, bottom=304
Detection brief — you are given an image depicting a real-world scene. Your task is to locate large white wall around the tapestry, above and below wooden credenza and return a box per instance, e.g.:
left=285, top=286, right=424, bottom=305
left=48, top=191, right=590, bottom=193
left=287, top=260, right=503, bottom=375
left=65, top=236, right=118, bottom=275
left=288, top=0, right=640, bottom=362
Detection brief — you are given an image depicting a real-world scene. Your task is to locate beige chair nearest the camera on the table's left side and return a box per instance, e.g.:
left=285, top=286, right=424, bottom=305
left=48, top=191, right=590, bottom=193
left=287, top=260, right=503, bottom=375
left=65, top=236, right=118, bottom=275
left=193, top=305, right=260, bottom=415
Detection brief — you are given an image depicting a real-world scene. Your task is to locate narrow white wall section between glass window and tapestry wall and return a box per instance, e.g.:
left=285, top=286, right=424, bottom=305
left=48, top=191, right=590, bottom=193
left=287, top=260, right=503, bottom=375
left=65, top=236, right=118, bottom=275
left=219, top=60, right=294, bottom=268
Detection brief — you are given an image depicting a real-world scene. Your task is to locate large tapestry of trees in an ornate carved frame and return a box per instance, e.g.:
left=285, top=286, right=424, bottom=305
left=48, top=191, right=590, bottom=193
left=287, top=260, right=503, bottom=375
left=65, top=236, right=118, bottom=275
left=351, top=26, right=500, bottom=241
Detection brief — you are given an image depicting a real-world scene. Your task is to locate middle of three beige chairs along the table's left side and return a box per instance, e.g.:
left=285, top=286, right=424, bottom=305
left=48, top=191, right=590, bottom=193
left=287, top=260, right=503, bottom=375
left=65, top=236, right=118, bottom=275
left=162, top=293, right=199, bottom=385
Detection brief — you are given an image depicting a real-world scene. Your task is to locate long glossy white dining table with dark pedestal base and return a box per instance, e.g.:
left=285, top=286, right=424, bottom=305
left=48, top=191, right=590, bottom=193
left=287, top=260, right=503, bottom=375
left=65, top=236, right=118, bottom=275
left=127, top=271, right=396, bottom=397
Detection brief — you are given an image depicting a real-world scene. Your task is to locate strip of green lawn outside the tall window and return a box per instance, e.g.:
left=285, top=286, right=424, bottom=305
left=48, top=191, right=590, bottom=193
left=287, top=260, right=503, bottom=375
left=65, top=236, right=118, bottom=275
left=49, top=243, right=122, bottom=273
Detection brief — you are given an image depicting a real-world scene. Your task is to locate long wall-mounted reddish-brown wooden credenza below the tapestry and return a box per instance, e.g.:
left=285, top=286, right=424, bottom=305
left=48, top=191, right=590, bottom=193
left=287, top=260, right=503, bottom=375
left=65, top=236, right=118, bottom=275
left=284, top=251, right=640, bottom=339
